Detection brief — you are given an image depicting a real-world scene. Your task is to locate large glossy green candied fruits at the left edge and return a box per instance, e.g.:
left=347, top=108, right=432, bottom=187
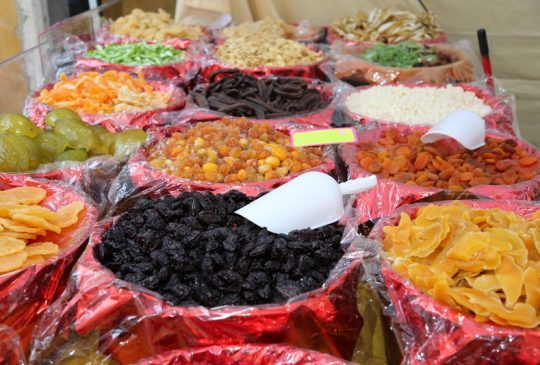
left=0, top=109, right=147, bottom=172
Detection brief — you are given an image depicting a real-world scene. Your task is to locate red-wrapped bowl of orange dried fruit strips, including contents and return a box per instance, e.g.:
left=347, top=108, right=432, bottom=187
left=25, top=70, right=185, bottom=131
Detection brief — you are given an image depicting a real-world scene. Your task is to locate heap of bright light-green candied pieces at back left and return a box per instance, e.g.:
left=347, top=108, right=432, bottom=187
left=86, top=42, right=184, bottom=66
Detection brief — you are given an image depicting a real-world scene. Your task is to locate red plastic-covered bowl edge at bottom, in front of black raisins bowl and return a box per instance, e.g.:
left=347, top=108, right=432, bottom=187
left=136, top=345, right=352, bottom=365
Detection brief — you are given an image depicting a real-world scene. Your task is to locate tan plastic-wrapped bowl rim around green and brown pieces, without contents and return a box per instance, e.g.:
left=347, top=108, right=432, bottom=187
left=332, top=42, right=478, bottom=85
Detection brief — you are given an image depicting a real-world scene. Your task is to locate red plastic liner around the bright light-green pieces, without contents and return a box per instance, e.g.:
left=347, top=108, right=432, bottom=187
left=73, top=39, right=200, bottom=86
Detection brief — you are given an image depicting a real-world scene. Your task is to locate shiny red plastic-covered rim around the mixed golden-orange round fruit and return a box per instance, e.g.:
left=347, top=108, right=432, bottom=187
left=109, top=124, right=336, bottom=202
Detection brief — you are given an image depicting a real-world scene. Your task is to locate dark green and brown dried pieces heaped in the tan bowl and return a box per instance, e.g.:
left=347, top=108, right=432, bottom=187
left=361, top=42, right=437, bottom=68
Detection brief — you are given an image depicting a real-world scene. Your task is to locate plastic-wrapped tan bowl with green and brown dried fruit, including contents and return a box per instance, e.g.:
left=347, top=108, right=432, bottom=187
left=333, top=42, right=474, bottom=85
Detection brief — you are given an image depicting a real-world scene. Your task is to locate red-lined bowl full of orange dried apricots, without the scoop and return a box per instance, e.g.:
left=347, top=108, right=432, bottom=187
left=340, top=126, right=540, bottom=222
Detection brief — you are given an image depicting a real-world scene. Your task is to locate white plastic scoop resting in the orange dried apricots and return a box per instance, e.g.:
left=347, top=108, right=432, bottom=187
left=421, top=110, right=486, bottom=150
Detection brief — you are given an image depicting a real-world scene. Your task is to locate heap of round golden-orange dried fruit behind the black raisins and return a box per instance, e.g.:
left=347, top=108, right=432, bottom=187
left=146, top=118, right=323, bottom=183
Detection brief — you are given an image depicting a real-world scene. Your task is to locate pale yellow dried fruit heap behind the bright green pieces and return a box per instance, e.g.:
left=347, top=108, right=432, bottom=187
left=111, top=9, right=202, bottom=42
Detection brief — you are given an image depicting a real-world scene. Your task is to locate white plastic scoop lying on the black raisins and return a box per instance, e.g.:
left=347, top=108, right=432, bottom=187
left=235, top=171, right=377, bottom=234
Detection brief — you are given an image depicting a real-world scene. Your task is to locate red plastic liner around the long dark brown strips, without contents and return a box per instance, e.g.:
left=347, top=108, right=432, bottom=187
left=182, top=79, right=349, bottom=128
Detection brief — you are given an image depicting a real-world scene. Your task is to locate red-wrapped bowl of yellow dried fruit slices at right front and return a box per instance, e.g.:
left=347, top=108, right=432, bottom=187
left=366, top=201, right=540, bottom=364
